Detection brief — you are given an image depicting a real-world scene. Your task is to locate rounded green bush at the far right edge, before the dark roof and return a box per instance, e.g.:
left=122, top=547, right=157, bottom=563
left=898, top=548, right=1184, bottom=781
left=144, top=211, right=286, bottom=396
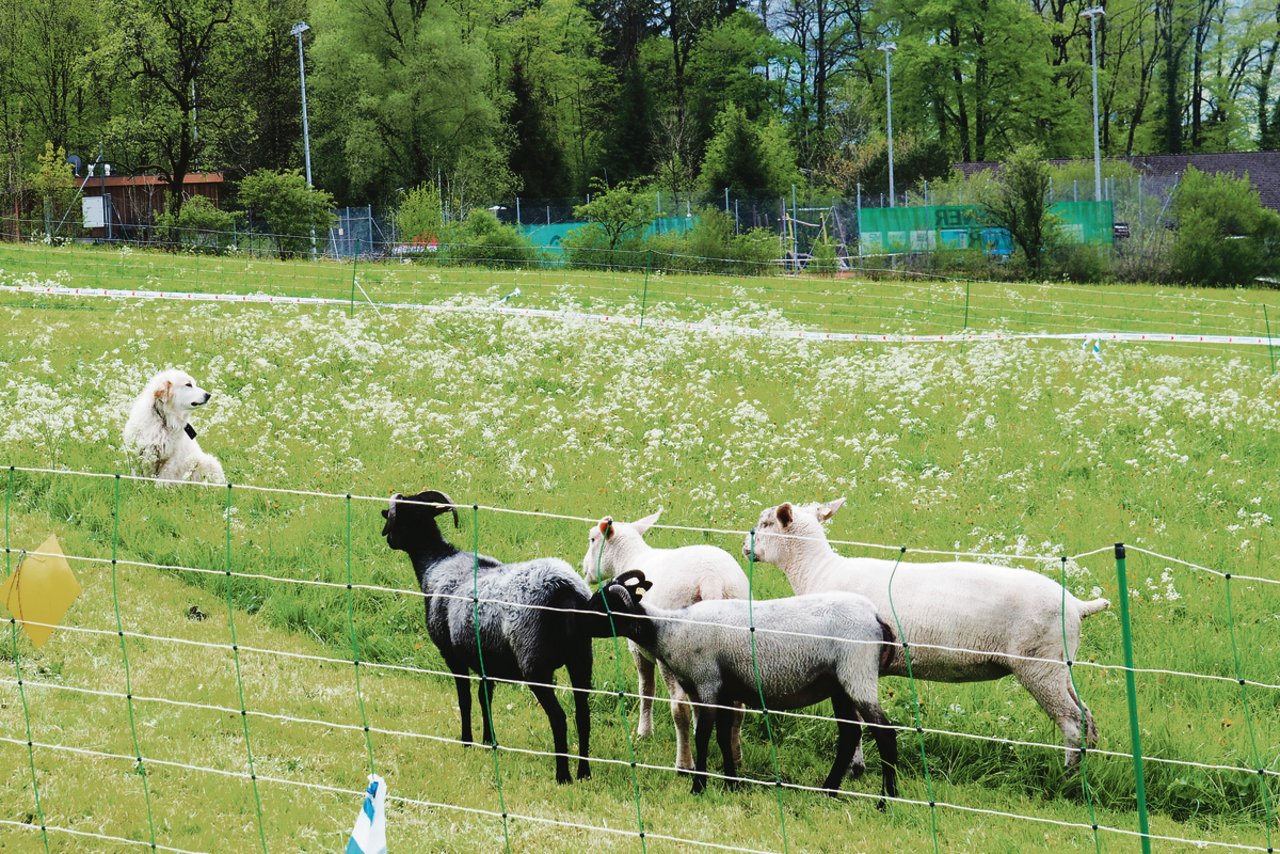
left=1172, top=168, right=1280, bottom=284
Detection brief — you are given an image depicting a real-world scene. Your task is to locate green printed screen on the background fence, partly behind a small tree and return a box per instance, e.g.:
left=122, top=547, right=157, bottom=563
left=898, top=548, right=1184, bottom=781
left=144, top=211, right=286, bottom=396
left=858, top=201, right=1115, bottom=255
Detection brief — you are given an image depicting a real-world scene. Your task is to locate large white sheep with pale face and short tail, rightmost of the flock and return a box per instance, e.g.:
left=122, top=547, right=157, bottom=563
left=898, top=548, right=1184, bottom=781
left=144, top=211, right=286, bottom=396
left=742, top=498, right=1110, bottom=768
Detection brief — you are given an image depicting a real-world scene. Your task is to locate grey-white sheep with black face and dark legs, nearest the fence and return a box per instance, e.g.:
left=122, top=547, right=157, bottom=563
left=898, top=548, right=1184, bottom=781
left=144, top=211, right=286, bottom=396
left=588, top=570, right=897, bottom=809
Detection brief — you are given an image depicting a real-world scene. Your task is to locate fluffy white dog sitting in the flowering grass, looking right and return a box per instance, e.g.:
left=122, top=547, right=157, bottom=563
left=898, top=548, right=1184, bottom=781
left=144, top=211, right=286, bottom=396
left=124, top=370, right=227, bottom=483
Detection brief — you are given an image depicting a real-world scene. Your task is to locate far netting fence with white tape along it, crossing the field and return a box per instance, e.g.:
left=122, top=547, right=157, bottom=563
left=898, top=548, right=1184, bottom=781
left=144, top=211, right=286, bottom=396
left=0, top=243, right=1280, bottom=373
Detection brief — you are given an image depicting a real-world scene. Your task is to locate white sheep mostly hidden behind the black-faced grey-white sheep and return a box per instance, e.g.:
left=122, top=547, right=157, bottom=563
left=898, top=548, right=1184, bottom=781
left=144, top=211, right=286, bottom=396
left=582, top=510, right=748, bottom=771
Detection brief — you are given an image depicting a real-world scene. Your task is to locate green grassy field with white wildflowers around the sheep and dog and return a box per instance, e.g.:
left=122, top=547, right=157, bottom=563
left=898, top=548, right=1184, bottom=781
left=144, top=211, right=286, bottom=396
left=0, top=246, right=1280, bottom=851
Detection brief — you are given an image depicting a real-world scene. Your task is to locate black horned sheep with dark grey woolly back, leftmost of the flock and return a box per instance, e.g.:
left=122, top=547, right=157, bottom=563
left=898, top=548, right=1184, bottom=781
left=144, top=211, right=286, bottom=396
left=383, top=490, right=591, bottom=784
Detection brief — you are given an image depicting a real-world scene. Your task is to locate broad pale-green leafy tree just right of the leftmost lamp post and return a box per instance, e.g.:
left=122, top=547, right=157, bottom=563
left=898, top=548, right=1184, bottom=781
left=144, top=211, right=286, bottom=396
left=308, top=0, right=517, bottom=206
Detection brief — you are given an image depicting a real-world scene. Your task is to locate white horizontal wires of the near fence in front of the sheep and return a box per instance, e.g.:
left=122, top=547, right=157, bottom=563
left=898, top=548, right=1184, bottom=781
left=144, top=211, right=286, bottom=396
left=0, top=466, right=1280, bottom=851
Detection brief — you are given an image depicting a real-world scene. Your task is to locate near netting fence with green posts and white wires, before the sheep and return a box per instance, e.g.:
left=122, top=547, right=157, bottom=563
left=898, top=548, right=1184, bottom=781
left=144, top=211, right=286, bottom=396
left=0, top=466, right=1280, bottom=851
